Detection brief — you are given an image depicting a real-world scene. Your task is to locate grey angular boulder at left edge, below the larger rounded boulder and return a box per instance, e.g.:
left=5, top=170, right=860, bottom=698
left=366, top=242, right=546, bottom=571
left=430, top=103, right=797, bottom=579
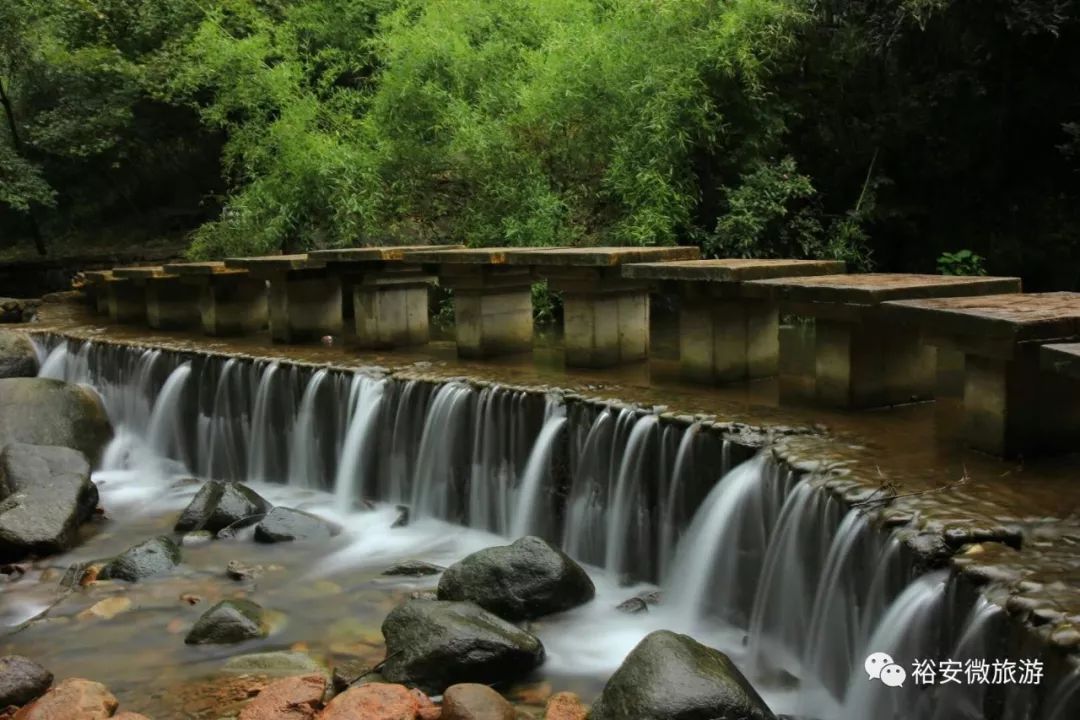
left=0, top=443, right=97, bottom=561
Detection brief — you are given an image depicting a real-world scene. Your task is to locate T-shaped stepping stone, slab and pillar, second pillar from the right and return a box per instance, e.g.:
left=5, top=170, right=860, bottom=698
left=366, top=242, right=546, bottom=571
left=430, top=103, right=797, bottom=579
left=743, top=273, right=1020, bottom=408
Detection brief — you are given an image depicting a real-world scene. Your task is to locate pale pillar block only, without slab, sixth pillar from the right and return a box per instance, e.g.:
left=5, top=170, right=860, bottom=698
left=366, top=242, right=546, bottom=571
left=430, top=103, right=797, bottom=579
left=351, top=280, right=429, bottom=350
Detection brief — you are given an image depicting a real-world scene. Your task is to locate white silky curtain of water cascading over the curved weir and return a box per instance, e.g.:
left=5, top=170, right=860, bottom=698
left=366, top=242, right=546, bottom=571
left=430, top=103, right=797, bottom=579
left=23, top=334, right=1080, bottom=720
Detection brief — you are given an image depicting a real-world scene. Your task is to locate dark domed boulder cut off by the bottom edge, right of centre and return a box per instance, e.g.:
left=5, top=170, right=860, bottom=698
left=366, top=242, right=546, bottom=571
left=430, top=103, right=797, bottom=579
left=589, top=630, right=775, bottom=720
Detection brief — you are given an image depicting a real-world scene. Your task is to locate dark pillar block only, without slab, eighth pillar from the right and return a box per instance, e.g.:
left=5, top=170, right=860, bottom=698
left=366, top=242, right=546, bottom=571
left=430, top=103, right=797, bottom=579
left=195, top=272, right=268, bottom=337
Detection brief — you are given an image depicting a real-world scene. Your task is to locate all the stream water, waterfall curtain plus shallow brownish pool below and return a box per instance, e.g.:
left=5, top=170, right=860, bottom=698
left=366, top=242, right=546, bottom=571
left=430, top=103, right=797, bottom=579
left=0, top=340, right=1080, bottom=720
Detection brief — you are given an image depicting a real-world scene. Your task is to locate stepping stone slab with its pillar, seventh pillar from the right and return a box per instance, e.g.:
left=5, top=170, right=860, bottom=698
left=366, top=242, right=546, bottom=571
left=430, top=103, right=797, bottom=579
left=225, top=255, right=332, bottom=342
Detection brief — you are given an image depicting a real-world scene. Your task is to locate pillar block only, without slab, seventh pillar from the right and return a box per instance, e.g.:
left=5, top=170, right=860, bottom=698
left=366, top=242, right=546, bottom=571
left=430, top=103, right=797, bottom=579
left=270, top=273, right=341, bottom=342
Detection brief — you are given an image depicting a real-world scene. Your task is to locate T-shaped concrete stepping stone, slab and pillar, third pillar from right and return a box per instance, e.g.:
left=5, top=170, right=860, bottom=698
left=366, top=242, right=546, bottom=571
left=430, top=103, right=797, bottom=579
left=622, top=258, right=845, bottom=382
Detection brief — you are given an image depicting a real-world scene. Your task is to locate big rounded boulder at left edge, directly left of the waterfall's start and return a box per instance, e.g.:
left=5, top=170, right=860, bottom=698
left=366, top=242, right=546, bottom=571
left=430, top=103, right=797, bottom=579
left=0, top=378, right=112, bottom=466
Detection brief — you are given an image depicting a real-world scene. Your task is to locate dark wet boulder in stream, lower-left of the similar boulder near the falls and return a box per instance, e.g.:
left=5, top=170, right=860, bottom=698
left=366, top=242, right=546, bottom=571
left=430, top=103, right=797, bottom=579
left=381, top=600, right=544, bottom=694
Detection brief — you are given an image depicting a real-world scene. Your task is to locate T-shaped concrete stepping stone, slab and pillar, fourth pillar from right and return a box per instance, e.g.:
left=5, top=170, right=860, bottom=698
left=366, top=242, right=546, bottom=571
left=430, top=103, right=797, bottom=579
left=505, top=247, right=701, bottom=368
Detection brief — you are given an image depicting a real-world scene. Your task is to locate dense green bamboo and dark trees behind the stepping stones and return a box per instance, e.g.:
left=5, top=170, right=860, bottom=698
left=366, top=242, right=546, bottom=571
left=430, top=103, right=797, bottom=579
left=0, top=0, right=1080, bottom=287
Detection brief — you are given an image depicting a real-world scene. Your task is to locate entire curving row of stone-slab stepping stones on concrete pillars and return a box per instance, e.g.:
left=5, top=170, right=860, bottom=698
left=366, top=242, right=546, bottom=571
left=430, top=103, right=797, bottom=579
left=86, top=245, right=1080, bottom=457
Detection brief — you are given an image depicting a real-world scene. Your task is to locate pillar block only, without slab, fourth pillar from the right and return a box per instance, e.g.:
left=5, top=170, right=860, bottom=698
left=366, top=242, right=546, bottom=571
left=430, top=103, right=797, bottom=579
left=563, top=290, right=649, bottom=368
